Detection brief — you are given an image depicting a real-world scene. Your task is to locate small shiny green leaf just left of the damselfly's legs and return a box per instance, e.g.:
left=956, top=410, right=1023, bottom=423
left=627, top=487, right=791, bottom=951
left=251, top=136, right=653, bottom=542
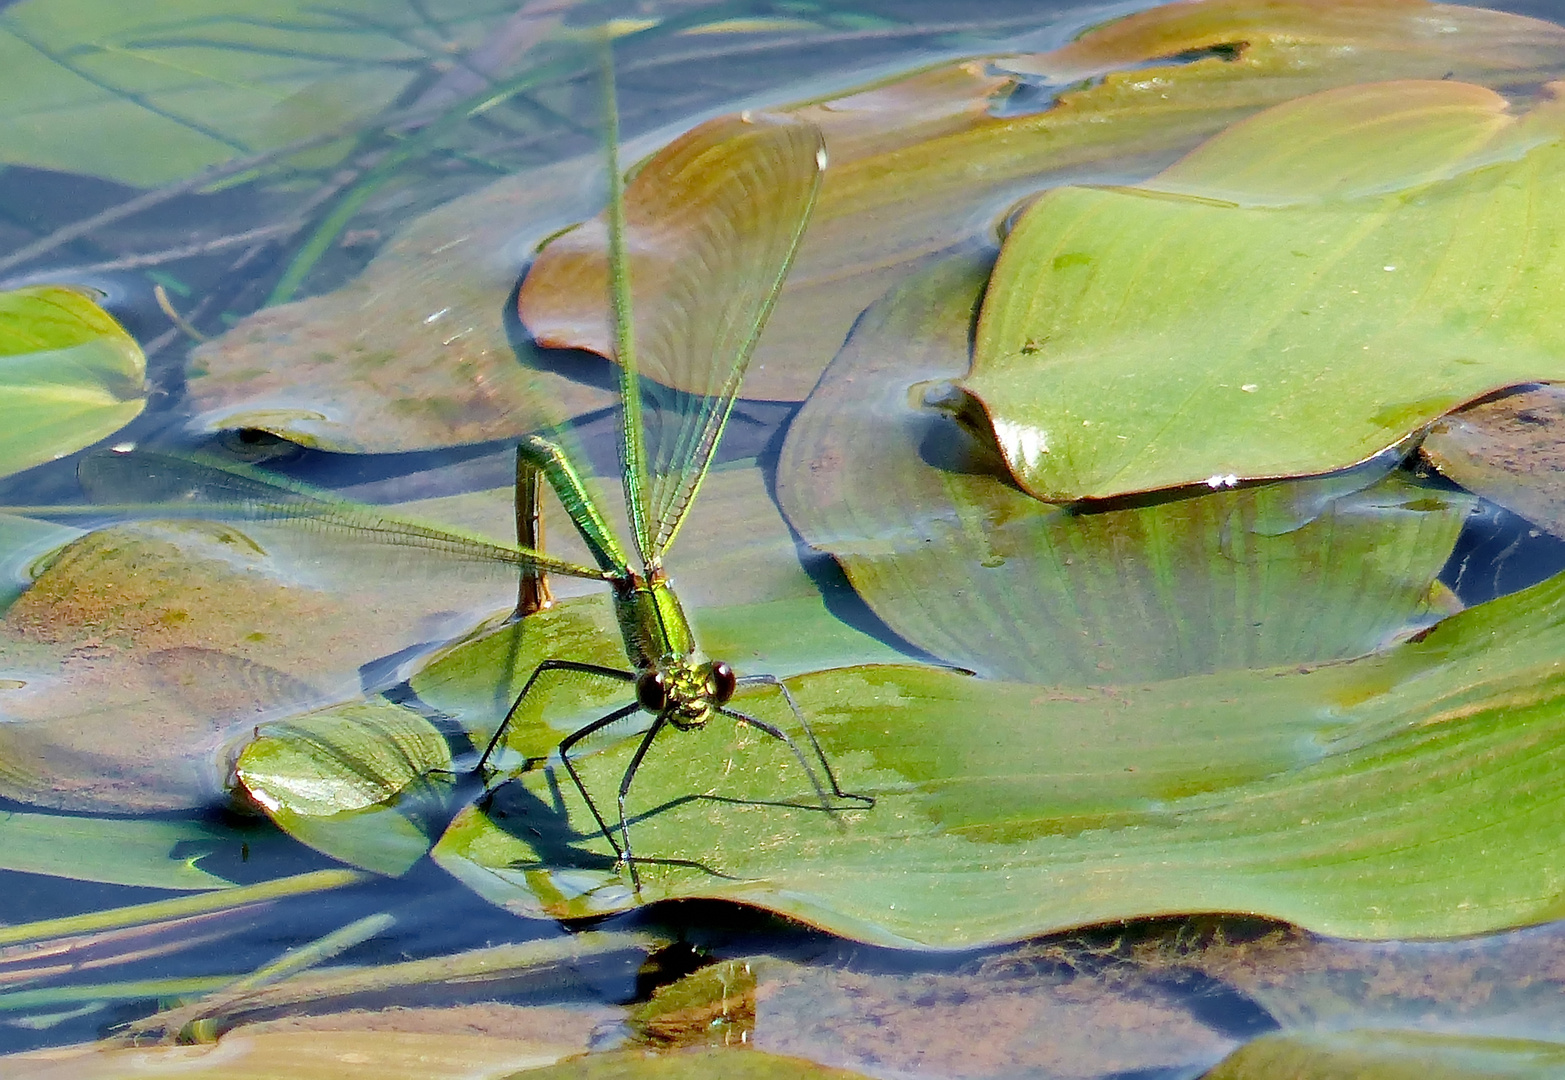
left=235, top=701, right=454, bottom=875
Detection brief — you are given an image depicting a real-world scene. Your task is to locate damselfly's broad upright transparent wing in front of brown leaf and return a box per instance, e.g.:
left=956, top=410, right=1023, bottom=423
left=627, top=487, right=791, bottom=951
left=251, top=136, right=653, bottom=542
left=621, top=114, right=826, bottom=567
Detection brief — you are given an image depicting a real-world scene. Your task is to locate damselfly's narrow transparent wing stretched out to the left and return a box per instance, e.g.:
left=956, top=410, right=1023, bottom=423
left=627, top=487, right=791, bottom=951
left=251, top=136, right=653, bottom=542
left=77, top=451, right=606, bottom=581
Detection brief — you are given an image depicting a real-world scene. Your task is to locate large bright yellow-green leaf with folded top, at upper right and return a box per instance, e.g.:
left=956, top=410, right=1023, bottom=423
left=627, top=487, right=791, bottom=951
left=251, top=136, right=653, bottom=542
left=956, top=81, right=1565, bottom=501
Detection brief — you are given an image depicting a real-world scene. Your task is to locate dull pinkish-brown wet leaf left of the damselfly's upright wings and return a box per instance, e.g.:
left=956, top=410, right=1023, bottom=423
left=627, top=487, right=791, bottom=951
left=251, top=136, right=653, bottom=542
left=189, top=151, right=613, bottom=452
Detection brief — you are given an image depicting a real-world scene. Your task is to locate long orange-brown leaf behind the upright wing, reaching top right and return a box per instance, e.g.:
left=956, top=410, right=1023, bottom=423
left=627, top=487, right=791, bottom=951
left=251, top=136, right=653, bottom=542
left=518, top=2, right=1565, bottom=399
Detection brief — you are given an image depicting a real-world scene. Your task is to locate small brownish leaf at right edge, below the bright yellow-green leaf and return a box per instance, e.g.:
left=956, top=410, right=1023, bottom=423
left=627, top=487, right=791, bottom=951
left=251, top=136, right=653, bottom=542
left=1423, top=387, right=1565, bottom=537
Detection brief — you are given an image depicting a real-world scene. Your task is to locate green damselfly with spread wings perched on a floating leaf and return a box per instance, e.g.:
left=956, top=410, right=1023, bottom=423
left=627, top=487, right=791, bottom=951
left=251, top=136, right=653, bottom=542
left=61, top=39, right=873, bottom=891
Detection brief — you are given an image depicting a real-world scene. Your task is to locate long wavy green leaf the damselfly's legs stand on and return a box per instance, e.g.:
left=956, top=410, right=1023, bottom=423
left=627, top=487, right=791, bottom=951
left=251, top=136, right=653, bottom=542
left=434, top=563, right=1565, bottom=949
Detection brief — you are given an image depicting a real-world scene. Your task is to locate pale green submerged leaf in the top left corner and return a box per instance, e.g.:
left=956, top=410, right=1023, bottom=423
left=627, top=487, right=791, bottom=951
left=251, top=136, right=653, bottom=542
left=0, top=0, right=513, bottom=186
